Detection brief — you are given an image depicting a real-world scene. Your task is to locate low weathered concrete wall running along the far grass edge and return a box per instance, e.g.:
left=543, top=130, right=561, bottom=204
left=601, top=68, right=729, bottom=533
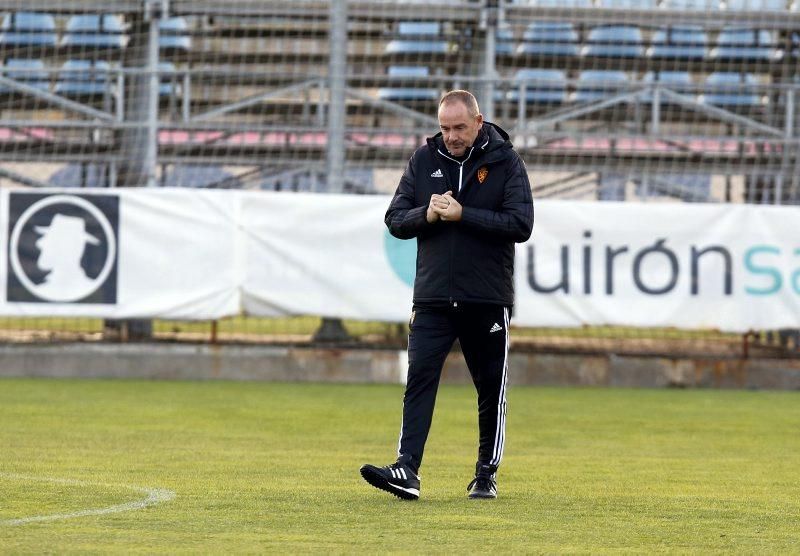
left=0, top=343, right=800, bottom=389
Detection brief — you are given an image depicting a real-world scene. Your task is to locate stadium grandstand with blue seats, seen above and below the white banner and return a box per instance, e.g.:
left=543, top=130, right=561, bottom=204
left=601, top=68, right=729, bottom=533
left=0, top=0, right=800, bottom=355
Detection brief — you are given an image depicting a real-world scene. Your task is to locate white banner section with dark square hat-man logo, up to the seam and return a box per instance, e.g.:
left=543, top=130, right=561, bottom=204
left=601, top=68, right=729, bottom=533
left=0, top=189, right=241, bottom=319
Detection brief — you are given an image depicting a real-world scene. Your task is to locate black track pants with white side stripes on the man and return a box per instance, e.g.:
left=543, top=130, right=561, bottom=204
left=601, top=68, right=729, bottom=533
left=398, top=304, right=509, bottom=470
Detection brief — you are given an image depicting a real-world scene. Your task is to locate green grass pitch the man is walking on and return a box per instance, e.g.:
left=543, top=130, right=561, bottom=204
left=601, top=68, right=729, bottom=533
left=0, top=379, right=800, bottom=553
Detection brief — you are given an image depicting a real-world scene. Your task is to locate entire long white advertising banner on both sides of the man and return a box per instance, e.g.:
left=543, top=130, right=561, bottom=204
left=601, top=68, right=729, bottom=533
left=0, top=189, right=800, bottom=332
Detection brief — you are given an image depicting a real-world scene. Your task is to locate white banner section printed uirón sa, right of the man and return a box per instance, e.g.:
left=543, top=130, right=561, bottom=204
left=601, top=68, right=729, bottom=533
left=516, top=202, right=800, bottom=332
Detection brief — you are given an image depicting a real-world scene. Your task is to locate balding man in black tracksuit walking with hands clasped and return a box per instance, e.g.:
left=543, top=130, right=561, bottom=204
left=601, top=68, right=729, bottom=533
left=361, top=91, right=533, bottom=500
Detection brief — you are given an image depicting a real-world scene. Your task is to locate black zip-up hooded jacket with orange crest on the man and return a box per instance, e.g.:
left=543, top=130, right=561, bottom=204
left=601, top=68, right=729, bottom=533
left=384, top=122, right=533, bottom=307
